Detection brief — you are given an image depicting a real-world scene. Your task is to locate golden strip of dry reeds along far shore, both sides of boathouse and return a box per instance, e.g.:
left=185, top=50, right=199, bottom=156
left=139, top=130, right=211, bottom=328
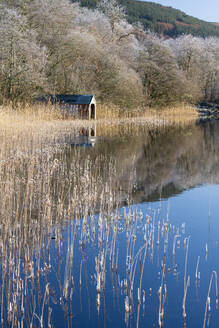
left=0, top=105, right=197, bottom=160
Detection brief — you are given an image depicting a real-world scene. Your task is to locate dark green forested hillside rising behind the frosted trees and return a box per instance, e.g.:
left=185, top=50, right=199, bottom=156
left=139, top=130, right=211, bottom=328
left=75, top=0, right=219, bottom=37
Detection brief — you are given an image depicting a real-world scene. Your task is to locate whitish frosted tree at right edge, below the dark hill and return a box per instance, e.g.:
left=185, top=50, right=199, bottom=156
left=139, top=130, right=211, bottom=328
left=168, top=35, right=219, bottom=100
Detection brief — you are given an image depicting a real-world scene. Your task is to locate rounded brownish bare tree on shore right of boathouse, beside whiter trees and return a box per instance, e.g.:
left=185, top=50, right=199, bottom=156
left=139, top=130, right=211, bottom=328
left=138, top=39, right=186, bottom=105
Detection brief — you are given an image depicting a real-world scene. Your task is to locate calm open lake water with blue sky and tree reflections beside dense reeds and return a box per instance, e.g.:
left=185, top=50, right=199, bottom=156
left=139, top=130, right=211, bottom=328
left=1, top=122, right=219, bottom=327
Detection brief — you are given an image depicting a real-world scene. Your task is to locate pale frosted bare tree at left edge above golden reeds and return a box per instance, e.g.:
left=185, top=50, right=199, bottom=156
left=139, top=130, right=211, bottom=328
left=0, top=6, right=47, bottom=101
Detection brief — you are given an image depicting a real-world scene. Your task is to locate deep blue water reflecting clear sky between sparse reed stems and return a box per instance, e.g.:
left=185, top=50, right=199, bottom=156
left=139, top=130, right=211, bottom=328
left=21, top=185, right=219, bottom=327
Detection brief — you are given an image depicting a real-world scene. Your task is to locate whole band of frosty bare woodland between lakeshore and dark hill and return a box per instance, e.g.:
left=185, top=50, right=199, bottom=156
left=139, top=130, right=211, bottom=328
left=0, top=0, right=219, bottom=109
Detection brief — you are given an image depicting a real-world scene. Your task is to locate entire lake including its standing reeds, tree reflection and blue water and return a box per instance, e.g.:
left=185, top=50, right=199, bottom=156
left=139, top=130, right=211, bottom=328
left=0, top=121, right=219, bottom=327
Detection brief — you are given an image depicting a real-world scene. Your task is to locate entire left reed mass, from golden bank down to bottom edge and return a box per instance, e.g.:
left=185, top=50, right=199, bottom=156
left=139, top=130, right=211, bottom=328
left=0, top=103, right=123, bottom=327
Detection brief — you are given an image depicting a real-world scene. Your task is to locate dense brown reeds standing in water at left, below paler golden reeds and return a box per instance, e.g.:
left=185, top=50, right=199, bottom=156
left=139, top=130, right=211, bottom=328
left=0, top=133, right=120, bottom=327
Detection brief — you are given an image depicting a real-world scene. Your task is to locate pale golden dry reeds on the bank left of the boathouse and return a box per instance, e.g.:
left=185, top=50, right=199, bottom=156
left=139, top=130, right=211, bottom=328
left=0, top=106, right=91, bottom=159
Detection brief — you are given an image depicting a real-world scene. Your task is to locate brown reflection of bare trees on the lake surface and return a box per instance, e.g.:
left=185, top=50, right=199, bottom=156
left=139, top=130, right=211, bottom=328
left=83, top=121, right=219, bottom=202
